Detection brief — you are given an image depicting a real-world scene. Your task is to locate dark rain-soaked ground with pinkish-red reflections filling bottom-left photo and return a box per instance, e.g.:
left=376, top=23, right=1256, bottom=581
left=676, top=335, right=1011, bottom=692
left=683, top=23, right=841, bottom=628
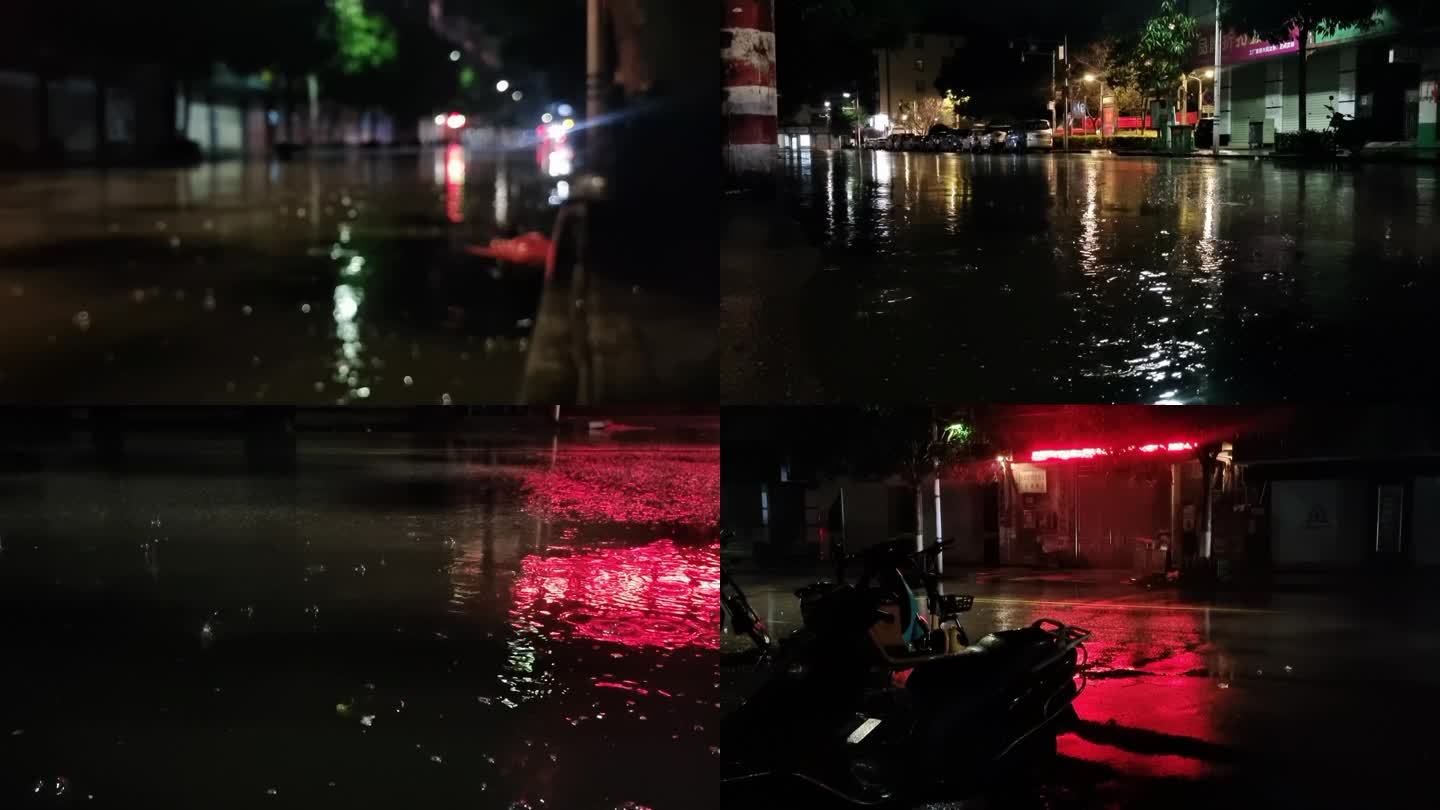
left=0, top=434, right=719, bottom=810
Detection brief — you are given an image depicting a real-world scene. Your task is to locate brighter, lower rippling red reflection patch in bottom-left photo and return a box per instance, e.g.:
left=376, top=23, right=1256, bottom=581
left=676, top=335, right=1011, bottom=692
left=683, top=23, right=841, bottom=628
left=513, top=540, right=720, bottom=650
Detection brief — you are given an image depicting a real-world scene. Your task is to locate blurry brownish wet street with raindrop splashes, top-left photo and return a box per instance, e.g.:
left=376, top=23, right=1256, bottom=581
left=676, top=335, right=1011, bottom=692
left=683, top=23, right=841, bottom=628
left=0, top=146, right=573, bottom=405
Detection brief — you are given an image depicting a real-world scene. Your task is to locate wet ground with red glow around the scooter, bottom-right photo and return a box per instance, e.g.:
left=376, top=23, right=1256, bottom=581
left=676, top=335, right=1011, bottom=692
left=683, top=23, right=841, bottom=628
left=721, top=572, right=1440, bottom=810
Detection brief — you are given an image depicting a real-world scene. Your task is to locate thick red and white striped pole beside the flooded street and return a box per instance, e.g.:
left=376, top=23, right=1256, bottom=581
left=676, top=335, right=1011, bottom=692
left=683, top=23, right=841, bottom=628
left=720, top=0, right=779, bottom=176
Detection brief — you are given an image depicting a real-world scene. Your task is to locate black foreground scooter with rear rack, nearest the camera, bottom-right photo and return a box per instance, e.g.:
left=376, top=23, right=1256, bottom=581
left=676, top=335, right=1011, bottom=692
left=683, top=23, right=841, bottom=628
left=721, top=573, right=1089, bottom=806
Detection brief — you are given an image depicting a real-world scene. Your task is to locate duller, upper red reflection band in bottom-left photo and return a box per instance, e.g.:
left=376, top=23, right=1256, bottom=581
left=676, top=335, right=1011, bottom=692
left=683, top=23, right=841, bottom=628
left=524, top=445, right=720, bottom=526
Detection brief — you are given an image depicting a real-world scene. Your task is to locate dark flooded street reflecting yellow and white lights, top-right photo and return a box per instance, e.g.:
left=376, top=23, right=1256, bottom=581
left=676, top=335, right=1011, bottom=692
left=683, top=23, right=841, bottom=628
left=723, top=151, right=1440, bottom=402
